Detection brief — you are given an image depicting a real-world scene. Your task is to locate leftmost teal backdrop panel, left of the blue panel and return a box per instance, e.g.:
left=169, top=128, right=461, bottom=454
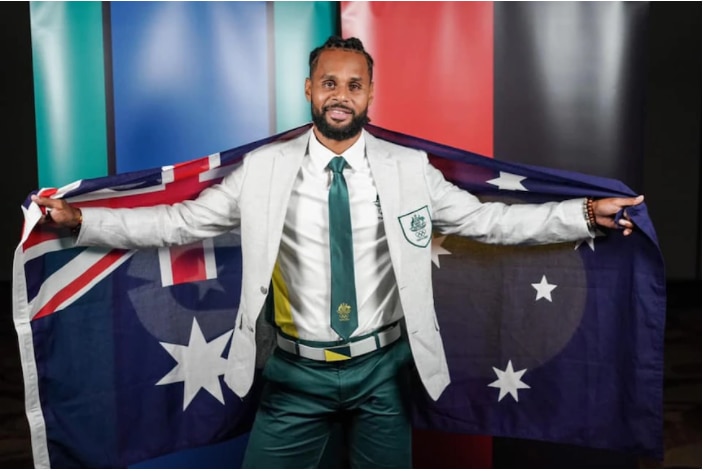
left=30, top=2, right=108, bottom=187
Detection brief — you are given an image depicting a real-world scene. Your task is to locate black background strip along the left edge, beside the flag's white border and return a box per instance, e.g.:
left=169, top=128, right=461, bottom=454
left=0, top=2, right=38, bottom=468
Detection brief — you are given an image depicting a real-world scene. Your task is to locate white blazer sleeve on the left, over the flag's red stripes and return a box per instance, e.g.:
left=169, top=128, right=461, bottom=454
left=76, top=157, right=248, bottom=249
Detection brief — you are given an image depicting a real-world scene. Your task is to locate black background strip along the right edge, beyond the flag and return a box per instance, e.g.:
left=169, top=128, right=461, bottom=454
left=644, top=2, right=703, bottom=284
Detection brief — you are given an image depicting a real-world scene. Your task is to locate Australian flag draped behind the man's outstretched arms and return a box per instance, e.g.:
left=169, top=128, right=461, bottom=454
left=13, top=125, right=665, bottom=468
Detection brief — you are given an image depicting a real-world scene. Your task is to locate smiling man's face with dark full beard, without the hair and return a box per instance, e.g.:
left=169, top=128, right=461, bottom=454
left=304, top=49, right=373, bottom=141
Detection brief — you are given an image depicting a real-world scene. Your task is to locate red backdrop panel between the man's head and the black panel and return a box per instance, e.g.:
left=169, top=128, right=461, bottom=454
left=341, top=2, right=493, bottom=468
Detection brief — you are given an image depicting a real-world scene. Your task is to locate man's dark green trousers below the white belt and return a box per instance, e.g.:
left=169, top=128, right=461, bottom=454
left=243, top=338, right=412, bottom=469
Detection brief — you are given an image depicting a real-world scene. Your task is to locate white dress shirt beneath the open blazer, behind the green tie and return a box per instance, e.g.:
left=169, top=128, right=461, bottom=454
left=273, top=132, right=402, bottom=341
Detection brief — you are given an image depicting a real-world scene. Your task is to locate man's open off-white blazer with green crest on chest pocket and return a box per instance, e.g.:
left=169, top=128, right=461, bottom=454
left=77, top=131, right=593, bottom=400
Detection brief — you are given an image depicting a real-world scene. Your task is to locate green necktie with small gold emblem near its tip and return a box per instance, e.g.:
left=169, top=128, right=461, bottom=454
left=328, top=157, right=358, bottom=340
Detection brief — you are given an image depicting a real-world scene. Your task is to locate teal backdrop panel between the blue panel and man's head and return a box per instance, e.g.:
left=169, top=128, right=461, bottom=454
left=274, top=2, right=339, bottom=132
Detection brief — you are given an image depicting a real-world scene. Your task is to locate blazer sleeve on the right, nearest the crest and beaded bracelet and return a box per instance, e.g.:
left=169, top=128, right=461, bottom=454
left=424, top=159, right=595, bottom=245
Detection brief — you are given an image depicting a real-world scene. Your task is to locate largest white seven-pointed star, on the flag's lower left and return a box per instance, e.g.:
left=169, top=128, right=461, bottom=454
left=157, top=318, right=232, bottom=410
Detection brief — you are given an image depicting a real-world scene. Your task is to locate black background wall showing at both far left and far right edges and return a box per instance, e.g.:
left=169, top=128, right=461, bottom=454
left=0, top=2, right=701, bottom=468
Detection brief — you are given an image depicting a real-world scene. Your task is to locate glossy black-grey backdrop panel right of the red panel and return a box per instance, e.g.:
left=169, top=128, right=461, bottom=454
left=494, top=2, right=649, bottom=191
